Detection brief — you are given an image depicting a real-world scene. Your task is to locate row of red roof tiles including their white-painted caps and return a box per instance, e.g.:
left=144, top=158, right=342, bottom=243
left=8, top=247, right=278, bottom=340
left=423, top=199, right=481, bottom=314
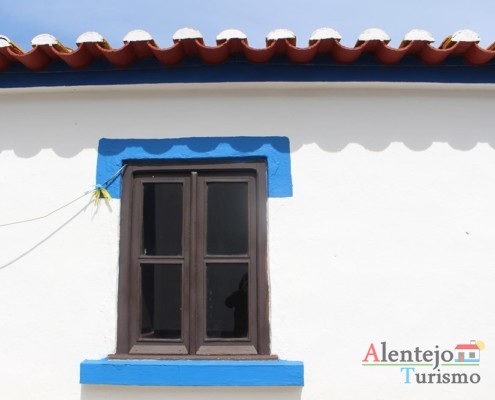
left=0, top=28, right=495, bottom=71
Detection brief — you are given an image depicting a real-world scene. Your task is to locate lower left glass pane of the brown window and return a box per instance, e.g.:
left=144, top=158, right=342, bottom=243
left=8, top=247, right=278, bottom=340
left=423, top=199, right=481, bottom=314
left=141, top=264, right=182, bottom=339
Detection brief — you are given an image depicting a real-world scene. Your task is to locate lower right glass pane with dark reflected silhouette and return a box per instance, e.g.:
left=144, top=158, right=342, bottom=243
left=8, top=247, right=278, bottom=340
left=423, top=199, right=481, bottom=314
left=206, top=264, right=249, bottom=338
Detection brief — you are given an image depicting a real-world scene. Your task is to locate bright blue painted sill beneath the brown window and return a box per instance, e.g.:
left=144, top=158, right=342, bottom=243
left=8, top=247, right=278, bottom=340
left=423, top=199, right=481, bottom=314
left=80, top=358, right=304, bottom=386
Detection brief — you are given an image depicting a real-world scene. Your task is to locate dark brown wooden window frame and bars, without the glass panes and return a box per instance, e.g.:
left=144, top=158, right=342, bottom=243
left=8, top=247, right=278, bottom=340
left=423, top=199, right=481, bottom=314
left=110, top=159, right=276, bottom=359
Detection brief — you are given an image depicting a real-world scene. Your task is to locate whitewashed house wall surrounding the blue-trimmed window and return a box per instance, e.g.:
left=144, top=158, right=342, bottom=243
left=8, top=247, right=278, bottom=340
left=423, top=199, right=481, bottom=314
left=0, top=84, right=495, bottom=400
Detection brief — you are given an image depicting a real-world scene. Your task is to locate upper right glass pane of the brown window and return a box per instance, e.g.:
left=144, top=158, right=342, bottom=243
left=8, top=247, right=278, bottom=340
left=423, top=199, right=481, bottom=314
left=206, top=182, right=248, bottom=255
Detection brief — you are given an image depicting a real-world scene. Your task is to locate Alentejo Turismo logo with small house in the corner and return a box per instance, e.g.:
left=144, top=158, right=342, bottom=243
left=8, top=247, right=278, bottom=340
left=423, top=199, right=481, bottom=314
left=362, top=340, right=485, bottom=384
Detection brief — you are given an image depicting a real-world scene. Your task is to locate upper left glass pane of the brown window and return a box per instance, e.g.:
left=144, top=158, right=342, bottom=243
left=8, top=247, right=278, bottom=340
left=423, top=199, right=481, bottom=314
left=143, top=183, right=182, bottom=256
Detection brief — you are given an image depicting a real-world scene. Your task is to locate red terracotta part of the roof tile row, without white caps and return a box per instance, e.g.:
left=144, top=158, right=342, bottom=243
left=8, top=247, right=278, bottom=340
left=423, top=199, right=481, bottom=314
left=0, top=30, right=495, bottom=70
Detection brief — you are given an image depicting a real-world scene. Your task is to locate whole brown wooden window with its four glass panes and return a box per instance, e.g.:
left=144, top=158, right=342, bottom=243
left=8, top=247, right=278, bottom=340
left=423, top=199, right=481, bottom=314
left=117, top=161, right=270, bottom=358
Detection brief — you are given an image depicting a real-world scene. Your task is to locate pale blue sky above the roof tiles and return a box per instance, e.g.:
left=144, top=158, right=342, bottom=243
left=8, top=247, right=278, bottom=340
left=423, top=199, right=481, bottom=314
left=0, top=0, right=495, bottom=50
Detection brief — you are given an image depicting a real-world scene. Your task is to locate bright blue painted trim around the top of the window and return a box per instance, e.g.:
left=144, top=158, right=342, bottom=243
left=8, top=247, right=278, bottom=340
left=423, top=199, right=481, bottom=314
left=96, top=136, right=292, bottom=198
